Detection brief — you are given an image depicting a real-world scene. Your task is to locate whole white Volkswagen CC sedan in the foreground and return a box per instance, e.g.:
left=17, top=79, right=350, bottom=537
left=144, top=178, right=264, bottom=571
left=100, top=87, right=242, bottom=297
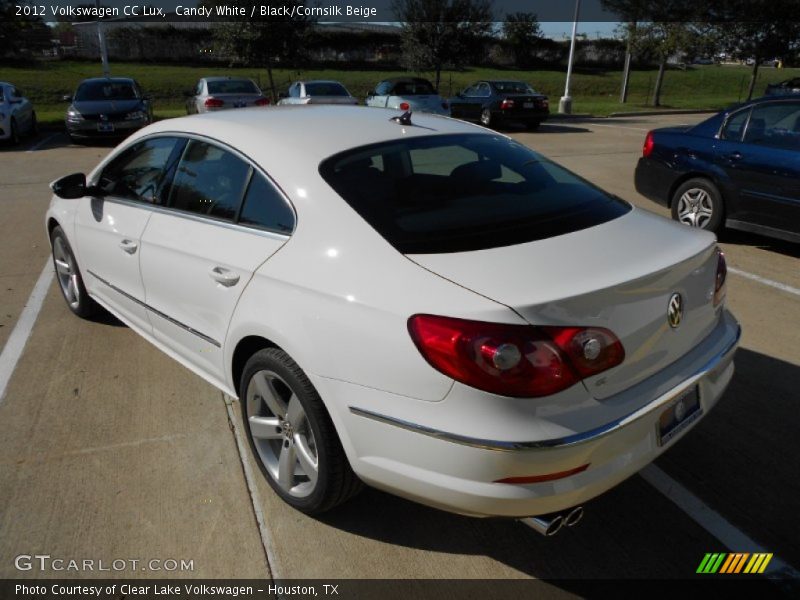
left=46, top=106, right=740, bottom=533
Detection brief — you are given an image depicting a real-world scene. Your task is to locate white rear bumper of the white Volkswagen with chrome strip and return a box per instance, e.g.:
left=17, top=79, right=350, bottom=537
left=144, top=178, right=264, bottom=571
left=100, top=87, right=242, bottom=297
left=315, top=312, right=740, bottom=517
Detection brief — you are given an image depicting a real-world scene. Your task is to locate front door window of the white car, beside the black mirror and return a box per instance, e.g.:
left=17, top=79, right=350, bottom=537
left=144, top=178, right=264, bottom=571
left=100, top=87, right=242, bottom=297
left=97, top=137, right=178, bottom=204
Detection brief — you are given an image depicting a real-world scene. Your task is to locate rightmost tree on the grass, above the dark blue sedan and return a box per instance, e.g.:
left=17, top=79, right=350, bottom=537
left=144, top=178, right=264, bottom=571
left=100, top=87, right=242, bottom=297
left=714, top=0, right=800, bottom=100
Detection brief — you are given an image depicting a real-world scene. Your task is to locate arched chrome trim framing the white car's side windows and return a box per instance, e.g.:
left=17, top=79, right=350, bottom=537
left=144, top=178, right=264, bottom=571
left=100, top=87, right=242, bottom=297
left=88, top=131, right=300, bottom=240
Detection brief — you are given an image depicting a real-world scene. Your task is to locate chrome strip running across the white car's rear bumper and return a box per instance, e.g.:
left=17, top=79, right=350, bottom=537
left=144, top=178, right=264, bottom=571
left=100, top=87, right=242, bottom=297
left=348, top=324, right=742, bottom=452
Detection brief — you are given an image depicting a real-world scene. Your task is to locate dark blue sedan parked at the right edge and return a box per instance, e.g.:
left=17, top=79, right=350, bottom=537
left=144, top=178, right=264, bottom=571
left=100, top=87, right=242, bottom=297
left=635, top=96, right=800, bottom=242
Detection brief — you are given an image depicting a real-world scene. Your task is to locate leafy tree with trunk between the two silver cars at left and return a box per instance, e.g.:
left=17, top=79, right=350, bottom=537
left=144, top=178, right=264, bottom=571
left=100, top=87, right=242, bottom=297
left=203, top=0, right=312, bottom=102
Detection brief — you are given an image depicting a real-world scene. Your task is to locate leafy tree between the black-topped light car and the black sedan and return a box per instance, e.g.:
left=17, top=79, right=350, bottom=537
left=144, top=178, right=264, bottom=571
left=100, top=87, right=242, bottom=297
left=392, top=0, right=492, bottom=90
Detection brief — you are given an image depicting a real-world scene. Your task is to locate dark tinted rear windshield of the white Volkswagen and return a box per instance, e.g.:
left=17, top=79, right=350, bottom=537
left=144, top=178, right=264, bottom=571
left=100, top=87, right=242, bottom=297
left=320, top=134, right=630, bottom=254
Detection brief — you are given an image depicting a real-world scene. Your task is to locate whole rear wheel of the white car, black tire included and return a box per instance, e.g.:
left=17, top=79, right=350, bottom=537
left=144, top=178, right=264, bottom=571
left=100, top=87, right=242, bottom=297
left=239, top=348, right=363, bottom=515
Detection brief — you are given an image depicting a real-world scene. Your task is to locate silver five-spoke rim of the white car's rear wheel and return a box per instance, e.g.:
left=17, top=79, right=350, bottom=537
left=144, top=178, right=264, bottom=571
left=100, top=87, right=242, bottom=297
left=247, top=370, right=319, bottom=498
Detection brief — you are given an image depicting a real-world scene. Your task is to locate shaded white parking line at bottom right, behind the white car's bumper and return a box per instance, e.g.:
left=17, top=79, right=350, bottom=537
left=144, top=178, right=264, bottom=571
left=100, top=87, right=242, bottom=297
left=639, top=464, right=800, bottom=580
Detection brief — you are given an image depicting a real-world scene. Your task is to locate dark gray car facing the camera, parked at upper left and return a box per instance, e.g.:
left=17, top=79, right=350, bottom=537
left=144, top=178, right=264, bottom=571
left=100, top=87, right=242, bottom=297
left=64, top=77, right=153, bottom=140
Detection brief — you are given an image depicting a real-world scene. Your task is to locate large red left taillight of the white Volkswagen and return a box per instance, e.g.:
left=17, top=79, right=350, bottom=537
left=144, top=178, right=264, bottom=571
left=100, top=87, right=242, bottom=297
left=408, top=315, right=625, bottom=398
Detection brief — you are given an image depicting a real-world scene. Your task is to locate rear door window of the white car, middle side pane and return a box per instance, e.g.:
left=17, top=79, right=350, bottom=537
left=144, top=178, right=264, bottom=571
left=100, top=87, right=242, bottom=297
left=169, top=140, right=250, bottom=221
